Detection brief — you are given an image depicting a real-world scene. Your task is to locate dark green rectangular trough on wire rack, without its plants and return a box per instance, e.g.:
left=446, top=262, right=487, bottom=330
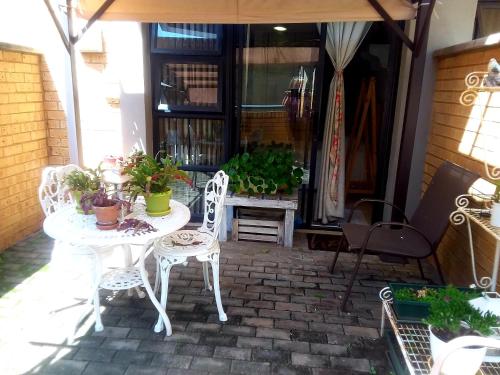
left=389, top=283, right=471, bottom=323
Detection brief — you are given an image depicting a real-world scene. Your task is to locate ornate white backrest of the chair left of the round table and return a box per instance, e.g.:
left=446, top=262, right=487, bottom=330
left=38, top=164, right=82, bottom=216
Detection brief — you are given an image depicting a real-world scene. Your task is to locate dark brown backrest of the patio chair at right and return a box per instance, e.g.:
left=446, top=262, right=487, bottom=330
left=410, top=161, right=479, bottom=251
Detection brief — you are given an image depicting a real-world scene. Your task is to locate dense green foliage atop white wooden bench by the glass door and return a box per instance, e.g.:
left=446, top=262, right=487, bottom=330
left=222, top=143, right=304, bottom=194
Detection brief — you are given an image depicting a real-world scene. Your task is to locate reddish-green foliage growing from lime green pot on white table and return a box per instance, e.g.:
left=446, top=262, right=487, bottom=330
left=125, top=155, right=191, bottom=196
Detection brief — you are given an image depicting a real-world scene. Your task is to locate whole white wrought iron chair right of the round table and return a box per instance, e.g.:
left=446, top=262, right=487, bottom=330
left=153, top=171, right=229, bottom=332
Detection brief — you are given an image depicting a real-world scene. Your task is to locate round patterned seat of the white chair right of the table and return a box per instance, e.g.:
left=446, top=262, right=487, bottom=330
left=154, top=230, right=213, bottom=256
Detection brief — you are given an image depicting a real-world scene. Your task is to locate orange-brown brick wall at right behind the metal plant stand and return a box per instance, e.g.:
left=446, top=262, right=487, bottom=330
left=423, top=44, right=500, bottom=284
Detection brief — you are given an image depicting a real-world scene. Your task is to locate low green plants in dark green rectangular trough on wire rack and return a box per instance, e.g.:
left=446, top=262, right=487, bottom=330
left=389, top=283, right=481, bottom=322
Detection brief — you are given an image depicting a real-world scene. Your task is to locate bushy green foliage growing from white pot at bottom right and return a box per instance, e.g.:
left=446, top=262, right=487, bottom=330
left=424, top=286, right=498, bottom=335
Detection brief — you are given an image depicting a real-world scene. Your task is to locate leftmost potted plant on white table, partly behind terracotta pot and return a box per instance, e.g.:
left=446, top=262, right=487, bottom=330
left=63, top=166, right=101, bottom=214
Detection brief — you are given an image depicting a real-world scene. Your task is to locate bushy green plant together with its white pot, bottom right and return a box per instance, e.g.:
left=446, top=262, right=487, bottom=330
left=424, top=287, right=497, bottom=375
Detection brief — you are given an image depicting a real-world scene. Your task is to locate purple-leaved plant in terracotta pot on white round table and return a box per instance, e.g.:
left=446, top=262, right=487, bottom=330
left=80, top=188, right=130, bottom=230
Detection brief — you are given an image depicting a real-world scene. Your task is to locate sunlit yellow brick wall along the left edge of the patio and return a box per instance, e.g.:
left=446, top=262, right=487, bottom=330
left=0, top=50, right=49, bottom=251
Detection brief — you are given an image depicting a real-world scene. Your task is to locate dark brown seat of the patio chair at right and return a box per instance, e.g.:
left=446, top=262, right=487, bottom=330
left=342, top=223, right=431, bottom=258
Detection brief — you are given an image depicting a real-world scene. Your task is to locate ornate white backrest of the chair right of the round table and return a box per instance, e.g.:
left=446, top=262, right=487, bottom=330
left=199, top=171, right=229, bottom=240
